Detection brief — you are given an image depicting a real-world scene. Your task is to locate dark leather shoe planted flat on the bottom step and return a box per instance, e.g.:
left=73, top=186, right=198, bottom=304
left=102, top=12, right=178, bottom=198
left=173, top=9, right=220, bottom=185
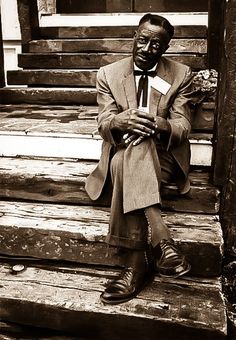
left=100, top=267, right=153, bottom=305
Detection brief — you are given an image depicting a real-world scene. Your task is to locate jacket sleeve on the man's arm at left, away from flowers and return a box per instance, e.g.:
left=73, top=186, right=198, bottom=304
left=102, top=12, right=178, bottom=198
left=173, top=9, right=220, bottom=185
left=96, top=67, right=122, bottom=144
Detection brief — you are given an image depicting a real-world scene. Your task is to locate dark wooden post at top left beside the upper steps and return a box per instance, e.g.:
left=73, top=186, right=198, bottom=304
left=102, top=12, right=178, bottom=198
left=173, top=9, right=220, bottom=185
left=17, top=0, right=40, bottom=52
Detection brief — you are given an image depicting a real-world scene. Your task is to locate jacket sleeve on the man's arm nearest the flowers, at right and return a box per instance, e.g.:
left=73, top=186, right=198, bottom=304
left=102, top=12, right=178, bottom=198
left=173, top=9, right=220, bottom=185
left=167, top=68, right=193, bottom=150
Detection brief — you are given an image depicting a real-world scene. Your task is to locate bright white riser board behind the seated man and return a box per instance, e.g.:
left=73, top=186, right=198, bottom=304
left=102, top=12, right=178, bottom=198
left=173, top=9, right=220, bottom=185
left=0, top=133, right=212, bottom=167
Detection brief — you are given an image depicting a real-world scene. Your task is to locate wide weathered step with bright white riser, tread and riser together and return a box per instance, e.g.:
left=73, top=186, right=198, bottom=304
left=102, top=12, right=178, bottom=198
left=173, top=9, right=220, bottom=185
left=0, top=105, right=213, bottom=166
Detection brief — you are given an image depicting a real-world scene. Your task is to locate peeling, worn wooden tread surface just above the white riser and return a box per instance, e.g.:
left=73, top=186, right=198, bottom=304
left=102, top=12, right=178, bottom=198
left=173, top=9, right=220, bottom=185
left=0, top=103, right=213, bottom=135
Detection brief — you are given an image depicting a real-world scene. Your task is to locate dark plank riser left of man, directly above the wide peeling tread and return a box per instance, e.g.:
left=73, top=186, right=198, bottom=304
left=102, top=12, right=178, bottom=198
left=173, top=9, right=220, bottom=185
left=0, top=87, right=96, bottom=105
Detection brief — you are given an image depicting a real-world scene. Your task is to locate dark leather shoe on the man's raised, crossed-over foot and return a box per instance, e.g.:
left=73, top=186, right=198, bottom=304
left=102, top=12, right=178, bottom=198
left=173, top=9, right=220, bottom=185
left=157, top=239, right=191, bottom=277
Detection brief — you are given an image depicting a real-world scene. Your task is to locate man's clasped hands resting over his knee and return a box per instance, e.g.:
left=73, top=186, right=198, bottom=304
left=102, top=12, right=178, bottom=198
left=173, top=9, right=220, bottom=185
left=111, top=109, right=170, bottom=146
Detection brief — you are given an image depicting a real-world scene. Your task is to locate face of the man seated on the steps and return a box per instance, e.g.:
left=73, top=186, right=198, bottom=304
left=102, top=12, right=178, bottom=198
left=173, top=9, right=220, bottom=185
left=133, top=22, right=170, bottom=70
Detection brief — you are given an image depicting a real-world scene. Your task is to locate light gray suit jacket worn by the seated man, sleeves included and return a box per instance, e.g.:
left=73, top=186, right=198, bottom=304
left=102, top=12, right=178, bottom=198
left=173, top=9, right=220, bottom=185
left=85, top=57, right=192, bottom=200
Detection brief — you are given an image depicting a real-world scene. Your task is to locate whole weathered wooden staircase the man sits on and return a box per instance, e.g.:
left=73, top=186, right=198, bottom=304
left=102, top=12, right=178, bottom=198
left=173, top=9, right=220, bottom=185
left=0, top=12, right=227, bottom=340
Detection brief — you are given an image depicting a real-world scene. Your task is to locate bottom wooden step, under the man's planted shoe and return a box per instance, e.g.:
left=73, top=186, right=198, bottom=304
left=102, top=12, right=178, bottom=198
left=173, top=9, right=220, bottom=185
left=0, top=264, right=226, bottom=340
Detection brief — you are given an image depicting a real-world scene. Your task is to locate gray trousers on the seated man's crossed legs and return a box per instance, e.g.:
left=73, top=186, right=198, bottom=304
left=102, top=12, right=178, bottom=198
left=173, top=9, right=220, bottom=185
left=106, top=138, right=177, bottom=249
